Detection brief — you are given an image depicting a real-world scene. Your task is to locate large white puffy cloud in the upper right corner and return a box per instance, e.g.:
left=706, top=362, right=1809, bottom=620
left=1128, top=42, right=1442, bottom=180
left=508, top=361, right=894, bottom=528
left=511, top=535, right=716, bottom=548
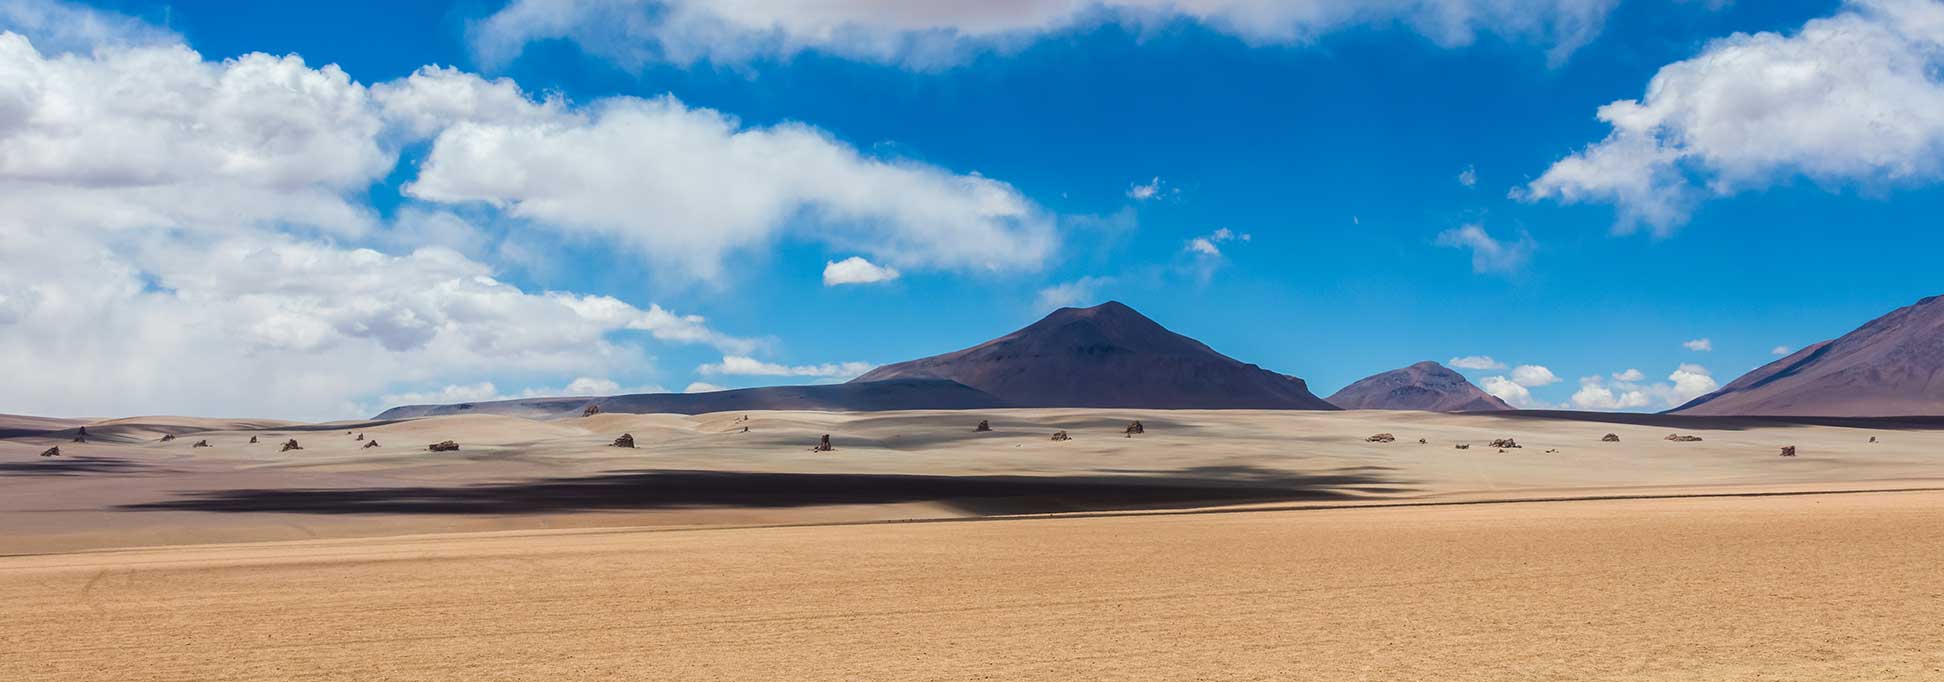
left=1514, top=0, right=1944, bottom=233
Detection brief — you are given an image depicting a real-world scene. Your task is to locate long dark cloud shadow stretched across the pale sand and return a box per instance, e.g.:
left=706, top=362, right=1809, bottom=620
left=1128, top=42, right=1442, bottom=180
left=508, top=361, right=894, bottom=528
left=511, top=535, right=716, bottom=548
left=122, top=468, right=1409, bottom=515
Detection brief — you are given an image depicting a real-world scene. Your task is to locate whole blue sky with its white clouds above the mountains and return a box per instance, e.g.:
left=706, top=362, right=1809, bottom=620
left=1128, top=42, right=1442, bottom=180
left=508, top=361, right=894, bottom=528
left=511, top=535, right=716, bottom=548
left=0, top=0, right=1944, bottom=418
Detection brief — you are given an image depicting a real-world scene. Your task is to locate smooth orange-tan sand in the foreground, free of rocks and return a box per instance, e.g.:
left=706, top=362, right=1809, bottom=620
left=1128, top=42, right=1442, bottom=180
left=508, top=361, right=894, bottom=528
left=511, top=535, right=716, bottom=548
left=0, top=492, right=1944, bottom=682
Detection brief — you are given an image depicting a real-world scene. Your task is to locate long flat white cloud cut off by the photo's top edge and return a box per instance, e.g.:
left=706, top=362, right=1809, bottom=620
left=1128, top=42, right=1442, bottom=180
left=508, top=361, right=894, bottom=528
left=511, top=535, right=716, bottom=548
left=470, top=0, right=1617, bottom=70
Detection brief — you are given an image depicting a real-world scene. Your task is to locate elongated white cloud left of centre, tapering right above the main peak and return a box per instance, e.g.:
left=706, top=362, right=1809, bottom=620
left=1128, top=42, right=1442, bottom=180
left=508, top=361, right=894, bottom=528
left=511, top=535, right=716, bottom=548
left=400, top=76, right=1054, bottom=280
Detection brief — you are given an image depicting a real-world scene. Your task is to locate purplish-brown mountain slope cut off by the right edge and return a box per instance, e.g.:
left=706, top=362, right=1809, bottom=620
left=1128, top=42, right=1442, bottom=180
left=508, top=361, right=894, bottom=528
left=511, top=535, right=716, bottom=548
left=1672, top=295, right=1944, bottom=416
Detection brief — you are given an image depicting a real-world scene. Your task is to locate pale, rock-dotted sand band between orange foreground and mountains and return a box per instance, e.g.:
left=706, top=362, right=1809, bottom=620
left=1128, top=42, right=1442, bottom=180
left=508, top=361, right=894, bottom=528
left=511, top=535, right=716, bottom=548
left=0, top=408, right=1944, bottom=554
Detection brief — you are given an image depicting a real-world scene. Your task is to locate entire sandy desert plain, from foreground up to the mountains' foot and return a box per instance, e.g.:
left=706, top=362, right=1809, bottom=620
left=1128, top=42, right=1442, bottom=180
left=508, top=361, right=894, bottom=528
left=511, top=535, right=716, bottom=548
left=0, top=408, right=1944, bottom=680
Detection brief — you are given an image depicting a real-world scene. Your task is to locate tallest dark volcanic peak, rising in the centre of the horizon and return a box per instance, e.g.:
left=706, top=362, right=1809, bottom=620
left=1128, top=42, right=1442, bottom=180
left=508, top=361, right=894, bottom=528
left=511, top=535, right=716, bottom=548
left=851, top=301, right=1334, bottom=410
